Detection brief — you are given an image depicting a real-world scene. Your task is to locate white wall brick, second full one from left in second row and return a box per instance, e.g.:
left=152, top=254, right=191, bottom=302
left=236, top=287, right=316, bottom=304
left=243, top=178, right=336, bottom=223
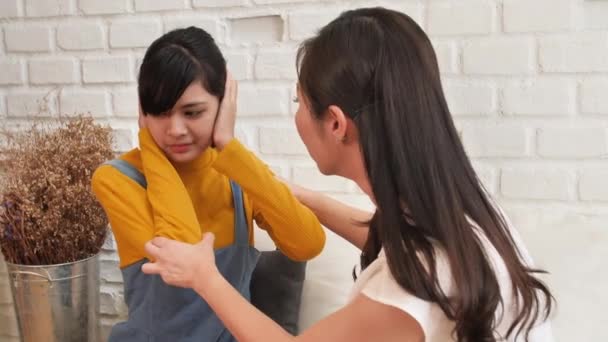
left=57, top=21, right=106, bottom=50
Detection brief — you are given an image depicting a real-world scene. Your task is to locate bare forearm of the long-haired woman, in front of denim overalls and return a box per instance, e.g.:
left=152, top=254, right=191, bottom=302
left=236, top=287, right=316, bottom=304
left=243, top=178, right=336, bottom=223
left=194, top=272, right=294, bottom=342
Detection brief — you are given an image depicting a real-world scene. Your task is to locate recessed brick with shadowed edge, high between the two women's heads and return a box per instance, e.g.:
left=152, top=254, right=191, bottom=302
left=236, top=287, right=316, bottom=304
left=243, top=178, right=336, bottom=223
left=230, top=15, right=283, bottom=44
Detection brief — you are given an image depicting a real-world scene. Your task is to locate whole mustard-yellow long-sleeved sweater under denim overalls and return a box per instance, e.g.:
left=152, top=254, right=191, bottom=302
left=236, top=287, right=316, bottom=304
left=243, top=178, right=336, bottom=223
left=92, top=129, right=325, bottom=267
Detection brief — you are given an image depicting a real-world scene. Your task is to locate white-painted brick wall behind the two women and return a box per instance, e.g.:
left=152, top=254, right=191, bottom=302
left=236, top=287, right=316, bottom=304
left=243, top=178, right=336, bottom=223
left=0, top=0, right=608, bottom=342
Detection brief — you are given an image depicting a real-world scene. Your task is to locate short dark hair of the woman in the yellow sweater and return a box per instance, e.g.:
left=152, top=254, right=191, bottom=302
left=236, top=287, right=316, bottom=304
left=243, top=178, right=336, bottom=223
left=137, top=26, right=226, bottom=115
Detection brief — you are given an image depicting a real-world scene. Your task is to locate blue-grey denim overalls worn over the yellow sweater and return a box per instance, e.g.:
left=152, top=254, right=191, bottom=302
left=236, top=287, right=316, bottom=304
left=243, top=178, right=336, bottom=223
left=106, top=159, right=259, bottom=342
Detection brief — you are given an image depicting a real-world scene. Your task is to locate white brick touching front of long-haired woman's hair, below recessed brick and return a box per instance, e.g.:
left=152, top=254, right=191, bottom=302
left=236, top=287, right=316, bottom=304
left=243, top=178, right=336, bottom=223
left=255, top=51, right=297, bottom=80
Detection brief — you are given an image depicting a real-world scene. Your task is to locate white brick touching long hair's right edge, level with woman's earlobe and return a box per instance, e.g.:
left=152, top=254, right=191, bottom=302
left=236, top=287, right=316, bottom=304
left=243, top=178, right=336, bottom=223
left=462, top=125, right=530, bottom=158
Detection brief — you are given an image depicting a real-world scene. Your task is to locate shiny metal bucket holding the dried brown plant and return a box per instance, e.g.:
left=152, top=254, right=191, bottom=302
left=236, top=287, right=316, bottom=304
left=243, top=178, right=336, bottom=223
left=6, top=255, right=99, bottom=342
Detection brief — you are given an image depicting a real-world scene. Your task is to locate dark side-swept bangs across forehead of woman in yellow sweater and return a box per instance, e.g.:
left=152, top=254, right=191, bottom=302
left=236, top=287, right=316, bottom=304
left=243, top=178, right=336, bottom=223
left=138, top=45, right=208, bottom=115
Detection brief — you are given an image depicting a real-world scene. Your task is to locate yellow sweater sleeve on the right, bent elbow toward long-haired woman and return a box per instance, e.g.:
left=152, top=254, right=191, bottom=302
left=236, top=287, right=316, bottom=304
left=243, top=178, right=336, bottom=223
left=213, top=139, right=325, bottom=260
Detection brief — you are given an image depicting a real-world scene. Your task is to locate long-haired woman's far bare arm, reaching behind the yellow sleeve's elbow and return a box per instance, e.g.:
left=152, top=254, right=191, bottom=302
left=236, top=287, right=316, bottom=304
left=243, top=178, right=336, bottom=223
left=296, top=188, right=373, bottom=249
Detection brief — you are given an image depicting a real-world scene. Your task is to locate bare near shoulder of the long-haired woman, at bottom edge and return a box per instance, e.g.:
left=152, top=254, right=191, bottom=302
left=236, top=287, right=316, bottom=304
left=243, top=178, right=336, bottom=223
left=297, top=294, right=424, bottom=342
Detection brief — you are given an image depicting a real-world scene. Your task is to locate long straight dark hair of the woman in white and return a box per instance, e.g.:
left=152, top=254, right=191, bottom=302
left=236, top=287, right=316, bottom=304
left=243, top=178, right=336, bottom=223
left=298, top=8, right=553, bottom=342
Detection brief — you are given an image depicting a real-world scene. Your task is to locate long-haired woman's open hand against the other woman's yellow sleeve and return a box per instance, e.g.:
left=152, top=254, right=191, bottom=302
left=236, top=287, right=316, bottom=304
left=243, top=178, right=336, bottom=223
left=142, top=233, right=218, bottom=288
